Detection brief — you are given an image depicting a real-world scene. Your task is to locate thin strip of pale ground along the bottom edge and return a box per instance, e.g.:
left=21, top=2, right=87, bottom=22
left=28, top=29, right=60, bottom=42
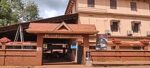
left=0, top=65, right=150, bottom=68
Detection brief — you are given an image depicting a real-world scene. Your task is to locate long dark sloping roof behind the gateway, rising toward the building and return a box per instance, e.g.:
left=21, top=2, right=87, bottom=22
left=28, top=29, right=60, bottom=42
left=0, top=13, right=78, bottom=34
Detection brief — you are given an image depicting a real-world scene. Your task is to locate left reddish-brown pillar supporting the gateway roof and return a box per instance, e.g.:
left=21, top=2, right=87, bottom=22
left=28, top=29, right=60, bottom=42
left=37, top=34, right=43, bottom=65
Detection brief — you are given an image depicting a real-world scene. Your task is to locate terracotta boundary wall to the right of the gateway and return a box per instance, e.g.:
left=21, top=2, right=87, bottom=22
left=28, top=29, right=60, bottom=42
left=91, top=51, right=150, bottom=64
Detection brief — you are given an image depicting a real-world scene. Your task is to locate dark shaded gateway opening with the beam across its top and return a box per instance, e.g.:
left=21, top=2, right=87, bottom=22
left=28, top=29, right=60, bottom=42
left=37, top=34, right=85, bottom=64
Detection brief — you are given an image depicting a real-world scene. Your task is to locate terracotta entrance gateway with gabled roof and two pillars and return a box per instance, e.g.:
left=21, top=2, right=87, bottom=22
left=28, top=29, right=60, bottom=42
left=26, top=23, right=98, bottom=65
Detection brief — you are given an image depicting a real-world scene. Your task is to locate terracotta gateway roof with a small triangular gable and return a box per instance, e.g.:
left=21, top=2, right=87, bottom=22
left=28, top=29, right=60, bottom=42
left=26, top=23, right=98, bottom=34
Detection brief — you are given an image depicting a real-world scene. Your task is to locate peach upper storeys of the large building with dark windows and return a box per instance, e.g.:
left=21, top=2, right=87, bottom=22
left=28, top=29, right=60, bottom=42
left=66, top=0, right=150, bottom=36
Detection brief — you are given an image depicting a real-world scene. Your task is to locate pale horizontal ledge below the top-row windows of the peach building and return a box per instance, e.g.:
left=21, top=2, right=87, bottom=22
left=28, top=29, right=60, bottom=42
left=78, top=7, right=150, bottom=17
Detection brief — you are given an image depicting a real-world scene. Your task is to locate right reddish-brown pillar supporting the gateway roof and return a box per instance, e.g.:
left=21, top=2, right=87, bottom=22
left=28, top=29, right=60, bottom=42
left=82, top=35, right=89, bottom=64
